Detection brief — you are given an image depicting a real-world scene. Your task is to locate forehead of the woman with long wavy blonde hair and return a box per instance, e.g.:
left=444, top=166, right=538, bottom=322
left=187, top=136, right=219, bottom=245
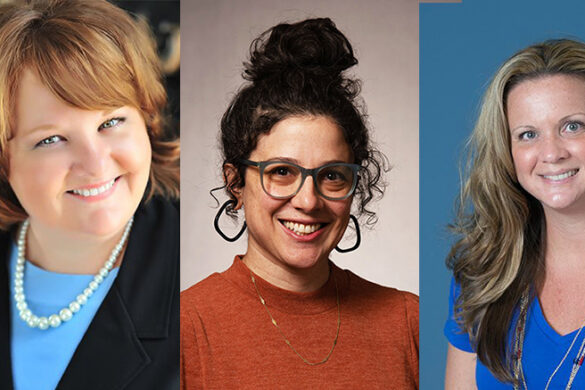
left=506, top=75, right=585, bottom=127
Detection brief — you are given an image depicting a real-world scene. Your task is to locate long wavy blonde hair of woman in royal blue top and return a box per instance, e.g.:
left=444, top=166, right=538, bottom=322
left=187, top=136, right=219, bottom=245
left=447, top=39, right=585, bottom=382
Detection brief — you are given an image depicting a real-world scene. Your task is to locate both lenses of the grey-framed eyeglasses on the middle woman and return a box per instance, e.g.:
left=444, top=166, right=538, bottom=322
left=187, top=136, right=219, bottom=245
left=262, top=162, right=354, bottom=199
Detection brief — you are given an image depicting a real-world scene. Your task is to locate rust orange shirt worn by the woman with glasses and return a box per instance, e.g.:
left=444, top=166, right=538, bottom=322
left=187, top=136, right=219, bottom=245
left=181, top=257, right=418, bottom=390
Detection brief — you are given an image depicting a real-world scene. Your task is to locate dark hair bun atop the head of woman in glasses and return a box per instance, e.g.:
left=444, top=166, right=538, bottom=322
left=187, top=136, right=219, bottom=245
left=244, top=18, right=358, bottom=83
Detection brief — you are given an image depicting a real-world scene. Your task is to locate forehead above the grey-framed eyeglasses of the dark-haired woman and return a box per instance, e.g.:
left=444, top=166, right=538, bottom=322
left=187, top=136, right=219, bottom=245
left=250, top=116, right=352, bottom=167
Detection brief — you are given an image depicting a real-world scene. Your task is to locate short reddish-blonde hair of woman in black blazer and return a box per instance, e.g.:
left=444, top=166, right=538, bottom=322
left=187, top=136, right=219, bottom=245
left=0, top=0, right=179, bottom=229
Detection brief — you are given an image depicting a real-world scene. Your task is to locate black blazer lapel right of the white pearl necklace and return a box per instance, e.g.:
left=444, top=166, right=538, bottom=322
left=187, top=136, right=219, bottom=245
left=57, top=199, right=179, bottom=390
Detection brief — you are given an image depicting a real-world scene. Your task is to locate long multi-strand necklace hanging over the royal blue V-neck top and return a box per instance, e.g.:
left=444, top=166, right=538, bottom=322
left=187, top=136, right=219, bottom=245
left=512, top=289, right=585, bottom=390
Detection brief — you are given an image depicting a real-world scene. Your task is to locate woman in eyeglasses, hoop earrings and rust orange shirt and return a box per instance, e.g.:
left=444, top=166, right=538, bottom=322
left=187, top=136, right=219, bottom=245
left=181, top=19, right=418, bottom=389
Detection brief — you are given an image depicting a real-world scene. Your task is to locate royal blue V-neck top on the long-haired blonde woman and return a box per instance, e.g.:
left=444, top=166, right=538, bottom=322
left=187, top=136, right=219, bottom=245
left=444, top=280, right=585, bottom=390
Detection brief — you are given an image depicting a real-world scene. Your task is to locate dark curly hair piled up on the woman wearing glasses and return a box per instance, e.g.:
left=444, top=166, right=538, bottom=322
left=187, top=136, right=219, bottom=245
left=221, top=18, right=387, bottom=225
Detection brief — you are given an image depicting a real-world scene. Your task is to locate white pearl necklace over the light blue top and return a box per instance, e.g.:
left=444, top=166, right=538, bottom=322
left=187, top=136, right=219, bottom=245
left=14, top=217, right=134, bottom=330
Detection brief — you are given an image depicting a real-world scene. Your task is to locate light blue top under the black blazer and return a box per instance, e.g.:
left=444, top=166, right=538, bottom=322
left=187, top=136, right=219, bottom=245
left=10, top=244, right=118, bottom=390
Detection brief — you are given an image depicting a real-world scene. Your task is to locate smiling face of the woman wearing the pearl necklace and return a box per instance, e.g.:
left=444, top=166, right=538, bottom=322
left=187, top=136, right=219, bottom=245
left=8, top=70, right=151, bottom=236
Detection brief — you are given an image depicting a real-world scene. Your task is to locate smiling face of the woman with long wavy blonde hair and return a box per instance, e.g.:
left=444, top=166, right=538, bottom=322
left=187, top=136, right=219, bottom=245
left=507, top=75, right=585, bottom=212
